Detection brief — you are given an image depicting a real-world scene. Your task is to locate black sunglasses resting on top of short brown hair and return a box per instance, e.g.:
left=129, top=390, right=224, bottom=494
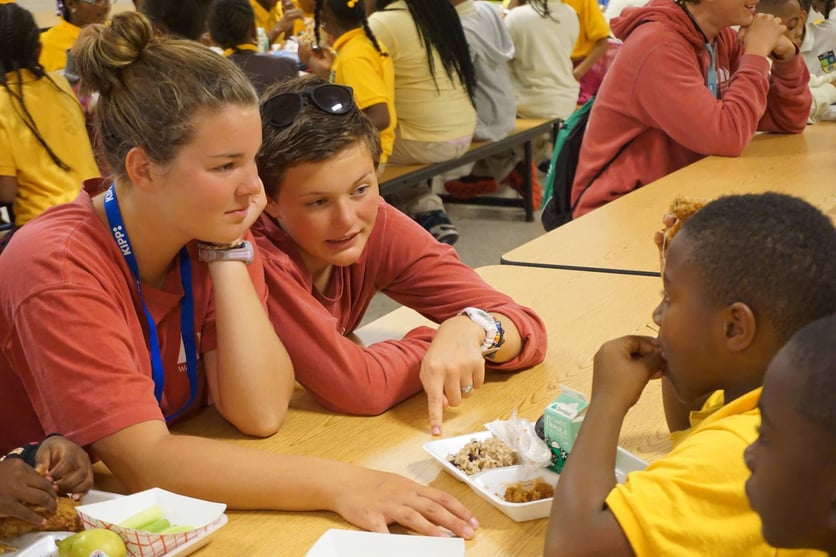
left=261, top=83, right=354, bottom=128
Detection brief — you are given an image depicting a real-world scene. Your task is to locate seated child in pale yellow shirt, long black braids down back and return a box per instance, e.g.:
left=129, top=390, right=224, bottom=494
left=369, top=0, right=476, bottom=244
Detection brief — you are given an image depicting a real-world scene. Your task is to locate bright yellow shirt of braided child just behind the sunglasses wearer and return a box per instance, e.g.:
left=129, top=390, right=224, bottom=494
left=331, top=27, right=397, bottom=163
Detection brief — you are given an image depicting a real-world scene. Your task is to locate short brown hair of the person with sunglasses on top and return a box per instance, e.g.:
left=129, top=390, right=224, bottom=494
left=256, top=75, right=380, bottom=199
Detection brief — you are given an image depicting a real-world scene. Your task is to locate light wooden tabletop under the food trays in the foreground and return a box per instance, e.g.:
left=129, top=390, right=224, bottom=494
left=103, top=265, right=670, bottom=557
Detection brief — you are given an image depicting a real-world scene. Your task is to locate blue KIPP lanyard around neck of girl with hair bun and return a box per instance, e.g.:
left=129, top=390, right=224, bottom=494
left=104, top=184, right=198, bottom=422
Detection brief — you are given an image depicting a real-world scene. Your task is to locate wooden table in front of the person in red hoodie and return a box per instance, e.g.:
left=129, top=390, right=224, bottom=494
left=501, top=122, right=836, bottom=276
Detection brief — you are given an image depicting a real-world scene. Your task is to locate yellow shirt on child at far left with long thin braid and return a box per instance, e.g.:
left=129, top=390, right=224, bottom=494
left=0, top=70, right=99, bottom=226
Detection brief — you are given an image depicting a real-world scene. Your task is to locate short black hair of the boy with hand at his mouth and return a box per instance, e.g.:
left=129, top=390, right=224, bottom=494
left=682, top=193, right=836, bottom=344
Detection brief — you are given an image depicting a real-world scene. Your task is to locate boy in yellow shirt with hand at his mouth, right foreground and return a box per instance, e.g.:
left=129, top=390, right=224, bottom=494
left=545, top=193, right=836, bottom=557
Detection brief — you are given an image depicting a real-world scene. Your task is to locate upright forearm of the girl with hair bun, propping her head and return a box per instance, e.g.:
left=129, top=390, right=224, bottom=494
left=206, top=261, right=294, bottom=436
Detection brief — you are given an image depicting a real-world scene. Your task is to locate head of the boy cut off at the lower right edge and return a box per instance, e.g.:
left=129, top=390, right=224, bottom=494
left=745, top=313, right=836, bottom=555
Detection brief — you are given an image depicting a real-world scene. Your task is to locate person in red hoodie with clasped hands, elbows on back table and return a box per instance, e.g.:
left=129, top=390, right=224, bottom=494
left=572, top=0, right=811, bottom=217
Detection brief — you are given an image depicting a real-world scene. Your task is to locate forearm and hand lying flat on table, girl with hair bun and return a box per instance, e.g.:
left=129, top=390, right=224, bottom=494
left=93, top=420, right=478, bottom=538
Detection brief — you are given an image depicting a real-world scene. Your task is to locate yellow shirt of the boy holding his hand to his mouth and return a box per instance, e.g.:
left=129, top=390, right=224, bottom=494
left=607, top=388, right=824, bottom=557
